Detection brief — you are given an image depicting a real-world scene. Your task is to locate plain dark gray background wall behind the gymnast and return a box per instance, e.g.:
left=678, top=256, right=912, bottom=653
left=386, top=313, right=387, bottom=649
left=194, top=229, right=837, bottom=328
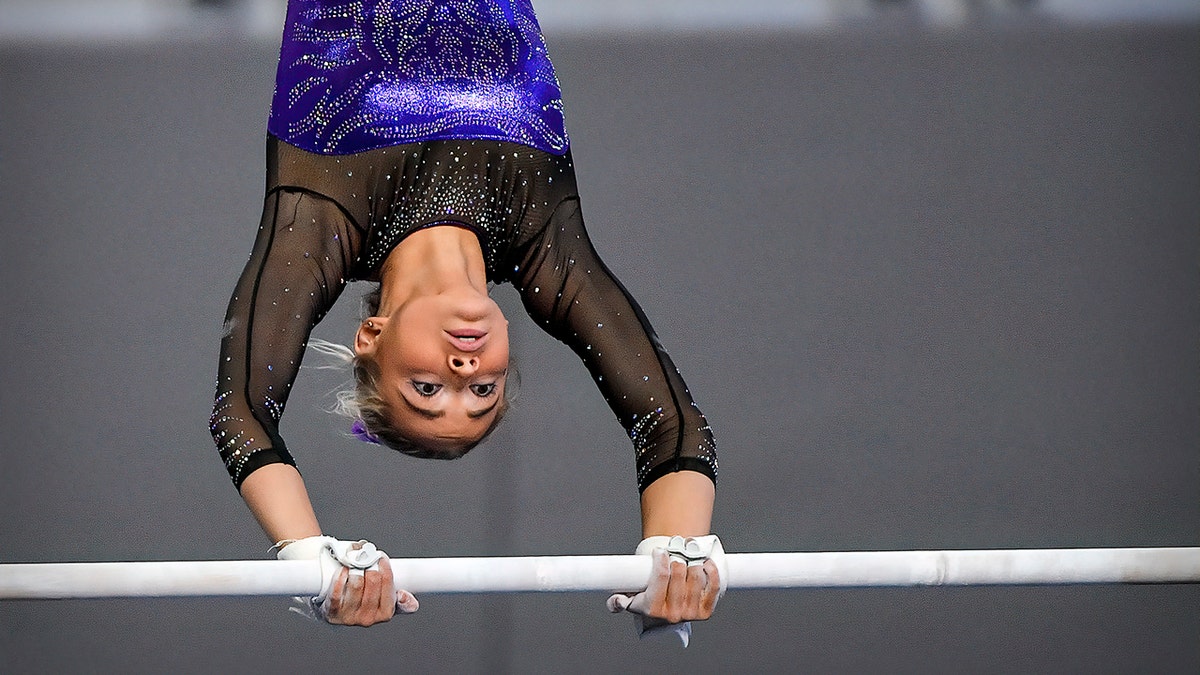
left=0, top=7, right=1200, bottom=673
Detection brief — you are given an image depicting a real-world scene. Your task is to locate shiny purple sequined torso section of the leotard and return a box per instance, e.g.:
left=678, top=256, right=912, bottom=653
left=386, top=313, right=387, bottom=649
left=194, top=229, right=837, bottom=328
left=268, top=0, right=568, bottom=155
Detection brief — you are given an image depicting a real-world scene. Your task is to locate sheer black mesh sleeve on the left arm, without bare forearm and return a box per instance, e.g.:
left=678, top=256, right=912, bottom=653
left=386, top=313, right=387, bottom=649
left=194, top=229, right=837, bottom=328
left=209, top=190, right=361, bottom=488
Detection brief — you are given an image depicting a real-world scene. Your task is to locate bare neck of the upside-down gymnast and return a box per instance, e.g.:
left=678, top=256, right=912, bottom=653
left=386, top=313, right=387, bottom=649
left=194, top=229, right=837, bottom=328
left=378, top=226, right=487, bottom=316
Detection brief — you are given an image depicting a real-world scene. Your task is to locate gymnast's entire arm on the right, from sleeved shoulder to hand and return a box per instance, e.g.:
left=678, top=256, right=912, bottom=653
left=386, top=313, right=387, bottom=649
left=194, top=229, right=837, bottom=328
left=512, top=199, right=722, bottom=638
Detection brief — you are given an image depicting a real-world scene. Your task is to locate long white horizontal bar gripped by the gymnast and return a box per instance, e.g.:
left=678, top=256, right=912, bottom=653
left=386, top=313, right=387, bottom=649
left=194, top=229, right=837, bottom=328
left=0, top=546, right=1200, bottom=599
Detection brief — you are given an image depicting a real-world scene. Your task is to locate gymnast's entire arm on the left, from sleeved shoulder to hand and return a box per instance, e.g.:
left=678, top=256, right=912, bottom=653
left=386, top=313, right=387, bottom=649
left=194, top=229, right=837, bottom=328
left=209, top=184, right=418, bottom=626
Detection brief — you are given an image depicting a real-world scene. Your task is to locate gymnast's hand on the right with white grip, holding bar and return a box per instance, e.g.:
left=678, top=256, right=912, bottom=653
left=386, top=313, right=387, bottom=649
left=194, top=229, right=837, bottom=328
left=608, top=534, right=725, bottom=646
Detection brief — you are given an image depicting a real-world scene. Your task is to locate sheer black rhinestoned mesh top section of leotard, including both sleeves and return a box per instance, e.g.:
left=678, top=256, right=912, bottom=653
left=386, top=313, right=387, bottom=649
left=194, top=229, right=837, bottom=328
left=211, top=138, right=718, bottom=489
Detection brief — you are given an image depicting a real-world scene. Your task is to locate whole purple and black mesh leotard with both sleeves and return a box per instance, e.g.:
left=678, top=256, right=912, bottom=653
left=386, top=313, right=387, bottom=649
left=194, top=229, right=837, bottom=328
left=209, top=0, right=716, bottom=490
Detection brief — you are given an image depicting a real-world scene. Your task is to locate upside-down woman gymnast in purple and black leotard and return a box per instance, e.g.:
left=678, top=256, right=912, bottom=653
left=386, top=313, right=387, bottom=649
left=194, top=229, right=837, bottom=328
left=210, top=0, right=724, bottom=644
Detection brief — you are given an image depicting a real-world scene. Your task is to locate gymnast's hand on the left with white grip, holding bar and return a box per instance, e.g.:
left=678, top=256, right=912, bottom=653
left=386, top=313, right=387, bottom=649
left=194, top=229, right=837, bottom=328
left=277, top=537, right=419, bottom=626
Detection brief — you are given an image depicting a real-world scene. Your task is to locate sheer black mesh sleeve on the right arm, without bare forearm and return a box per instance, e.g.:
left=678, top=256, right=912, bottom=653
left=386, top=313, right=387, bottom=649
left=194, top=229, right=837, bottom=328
left=512, top=198, right=716, bottom=490
